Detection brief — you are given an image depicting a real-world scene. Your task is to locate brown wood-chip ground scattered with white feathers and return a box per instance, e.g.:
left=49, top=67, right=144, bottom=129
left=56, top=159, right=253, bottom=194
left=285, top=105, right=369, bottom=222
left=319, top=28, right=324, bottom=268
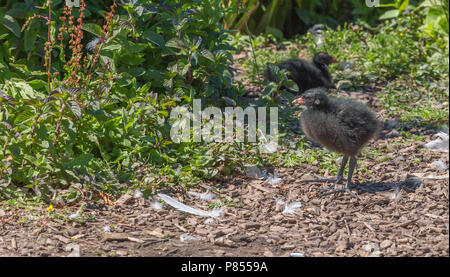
left=0, top=49, right=449, bottom=257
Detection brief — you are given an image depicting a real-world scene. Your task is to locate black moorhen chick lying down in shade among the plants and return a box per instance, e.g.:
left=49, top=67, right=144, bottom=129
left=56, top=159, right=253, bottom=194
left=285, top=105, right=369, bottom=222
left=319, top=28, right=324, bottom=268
left=264, top=52, right=337, bottom=93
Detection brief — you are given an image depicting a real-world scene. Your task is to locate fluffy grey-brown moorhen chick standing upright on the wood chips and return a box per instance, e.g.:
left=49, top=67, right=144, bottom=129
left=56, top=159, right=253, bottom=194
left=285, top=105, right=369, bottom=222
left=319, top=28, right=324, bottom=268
left=293, top=89, right=380, bottom=198
